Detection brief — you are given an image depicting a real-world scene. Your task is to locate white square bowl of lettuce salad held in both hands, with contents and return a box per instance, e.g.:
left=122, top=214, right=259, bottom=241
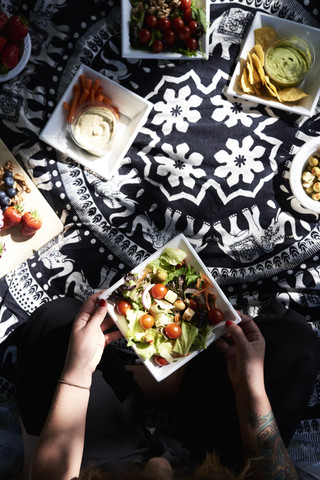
left=101, top=234, right=241, bottom=382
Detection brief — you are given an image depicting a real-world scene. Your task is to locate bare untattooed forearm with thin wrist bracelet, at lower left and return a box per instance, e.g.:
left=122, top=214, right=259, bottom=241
left=30, top=376, right=91, bottom=480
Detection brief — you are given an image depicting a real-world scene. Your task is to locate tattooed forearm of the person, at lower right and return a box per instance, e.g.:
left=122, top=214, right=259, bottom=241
left=236, top=386, right=298, bottom=480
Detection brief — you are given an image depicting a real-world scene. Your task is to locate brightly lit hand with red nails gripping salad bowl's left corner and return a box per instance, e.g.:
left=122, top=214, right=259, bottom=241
left=63, top=292, right=122, bottom=386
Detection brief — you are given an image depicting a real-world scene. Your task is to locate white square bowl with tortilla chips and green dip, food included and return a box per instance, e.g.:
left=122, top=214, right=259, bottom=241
left=227, top=12, right=320, bottom=116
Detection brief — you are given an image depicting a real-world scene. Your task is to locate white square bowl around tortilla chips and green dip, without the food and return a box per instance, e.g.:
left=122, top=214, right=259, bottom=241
left=227, top=12, right=320, bottom=117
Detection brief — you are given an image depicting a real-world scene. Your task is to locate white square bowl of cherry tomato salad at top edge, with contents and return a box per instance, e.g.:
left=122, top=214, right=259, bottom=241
left=121, top=0, right=210, bottom=60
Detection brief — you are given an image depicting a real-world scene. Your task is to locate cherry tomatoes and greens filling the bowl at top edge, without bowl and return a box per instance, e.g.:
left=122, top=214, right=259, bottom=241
left=129, top=0, right=207, bottom=57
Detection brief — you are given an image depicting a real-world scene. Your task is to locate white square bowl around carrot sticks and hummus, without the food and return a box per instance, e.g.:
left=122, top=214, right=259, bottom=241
left=40, top=65, right=152, bottom=180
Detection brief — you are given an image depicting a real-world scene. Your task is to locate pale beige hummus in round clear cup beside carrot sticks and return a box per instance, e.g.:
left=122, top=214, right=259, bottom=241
left=71, top=105, right=116, bottom=157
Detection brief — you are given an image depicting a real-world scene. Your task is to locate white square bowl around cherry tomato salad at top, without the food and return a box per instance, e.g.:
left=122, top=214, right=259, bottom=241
left=121, top=0, right=210, bottom=60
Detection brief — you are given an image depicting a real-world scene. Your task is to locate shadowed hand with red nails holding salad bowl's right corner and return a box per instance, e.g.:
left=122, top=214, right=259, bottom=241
left=215, top=312, right=265, bottom=393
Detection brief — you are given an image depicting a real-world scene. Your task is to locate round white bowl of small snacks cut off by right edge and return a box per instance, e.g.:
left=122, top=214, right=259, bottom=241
left=289, top=137, right=320, bottom=213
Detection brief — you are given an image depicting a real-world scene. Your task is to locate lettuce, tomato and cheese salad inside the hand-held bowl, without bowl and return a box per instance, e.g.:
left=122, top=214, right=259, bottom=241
left=112, top=247, right=224, bottom=366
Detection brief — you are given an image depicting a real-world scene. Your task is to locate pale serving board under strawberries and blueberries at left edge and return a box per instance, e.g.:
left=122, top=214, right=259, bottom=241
left=0, top=139, right=63, bottom=277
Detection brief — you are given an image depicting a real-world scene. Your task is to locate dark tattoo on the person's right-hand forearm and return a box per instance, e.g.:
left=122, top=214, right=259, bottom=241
left=248, top=410, right=298, bottom=480
